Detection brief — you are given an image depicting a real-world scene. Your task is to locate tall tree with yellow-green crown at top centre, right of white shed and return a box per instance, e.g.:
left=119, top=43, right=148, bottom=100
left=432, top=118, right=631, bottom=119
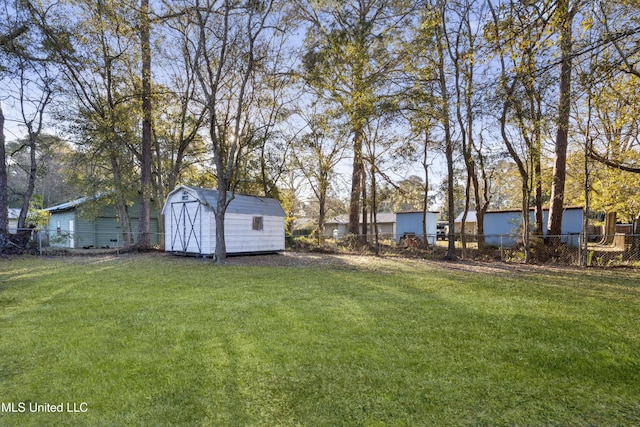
left=298, top=0, right=417, bottom=239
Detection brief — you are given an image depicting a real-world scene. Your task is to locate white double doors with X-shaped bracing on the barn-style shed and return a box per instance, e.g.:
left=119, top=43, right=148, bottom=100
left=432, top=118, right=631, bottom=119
left=170, top=201, right=202, bottom=254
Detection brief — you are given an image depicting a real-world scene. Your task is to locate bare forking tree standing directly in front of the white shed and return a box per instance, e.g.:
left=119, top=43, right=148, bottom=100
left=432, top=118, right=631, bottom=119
left=184, top=0, right=280, bottom=263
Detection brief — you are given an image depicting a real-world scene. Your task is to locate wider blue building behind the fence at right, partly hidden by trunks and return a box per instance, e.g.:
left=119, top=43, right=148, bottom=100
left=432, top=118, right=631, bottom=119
left=484, top=207, right=584, bottom=247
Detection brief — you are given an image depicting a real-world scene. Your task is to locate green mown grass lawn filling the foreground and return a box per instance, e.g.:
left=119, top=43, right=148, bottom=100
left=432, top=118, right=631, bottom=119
left=0, top=256, right=640, bottom=426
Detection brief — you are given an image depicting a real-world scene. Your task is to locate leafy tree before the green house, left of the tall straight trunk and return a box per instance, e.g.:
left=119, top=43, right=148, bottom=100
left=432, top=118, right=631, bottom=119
left=31, top=0, right=139, bottom=245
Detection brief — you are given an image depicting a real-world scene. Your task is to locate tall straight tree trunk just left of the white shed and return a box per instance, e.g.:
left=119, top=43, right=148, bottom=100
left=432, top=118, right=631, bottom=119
left=137, top=0, right=152, bottom=249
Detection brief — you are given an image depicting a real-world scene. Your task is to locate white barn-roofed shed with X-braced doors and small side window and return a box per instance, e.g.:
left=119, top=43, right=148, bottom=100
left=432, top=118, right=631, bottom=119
left=162, top=186, right=285, bottom=256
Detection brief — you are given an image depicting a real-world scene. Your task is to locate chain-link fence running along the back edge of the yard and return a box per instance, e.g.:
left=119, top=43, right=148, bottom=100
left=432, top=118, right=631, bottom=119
left=12, top=230, right=640, bottom=268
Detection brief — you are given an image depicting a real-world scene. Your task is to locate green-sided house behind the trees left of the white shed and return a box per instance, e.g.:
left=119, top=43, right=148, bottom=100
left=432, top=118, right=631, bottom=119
left=45, top=197, right=159, bottom=249
